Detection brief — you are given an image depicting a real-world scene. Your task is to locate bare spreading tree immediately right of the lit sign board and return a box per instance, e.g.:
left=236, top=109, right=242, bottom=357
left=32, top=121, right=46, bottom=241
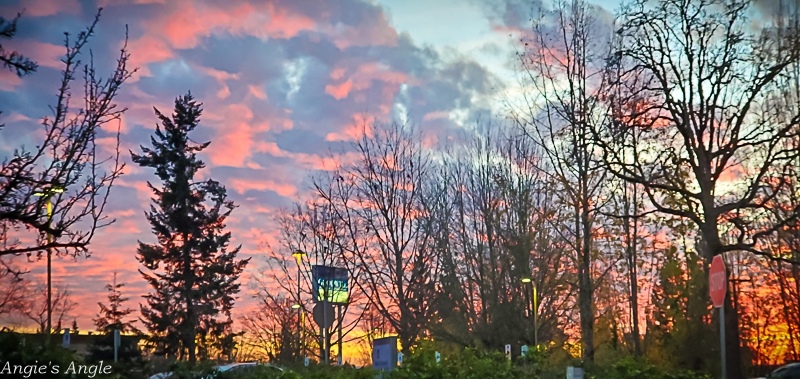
left=315, top=123, right=438, bottom=349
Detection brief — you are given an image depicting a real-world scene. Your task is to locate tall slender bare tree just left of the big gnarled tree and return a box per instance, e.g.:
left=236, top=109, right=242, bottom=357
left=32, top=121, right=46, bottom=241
left=510, top=0, right=610, bottom=361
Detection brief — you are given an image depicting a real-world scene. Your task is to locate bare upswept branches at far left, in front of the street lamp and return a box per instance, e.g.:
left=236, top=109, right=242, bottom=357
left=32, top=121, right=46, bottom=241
left=0, top=10, right=135, bottom=257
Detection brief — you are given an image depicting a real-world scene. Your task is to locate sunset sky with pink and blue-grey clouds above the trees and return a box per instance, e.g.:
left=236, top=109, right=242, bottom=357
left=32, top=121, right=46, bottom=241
left=0, top=0, right=615, bottom=330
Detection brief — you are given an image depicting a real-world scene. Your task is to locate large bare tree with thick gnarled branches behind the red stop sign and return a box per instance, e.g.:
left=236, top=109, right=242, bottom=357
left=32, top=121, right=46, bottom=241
left=597, top=0, right=800, bottom=379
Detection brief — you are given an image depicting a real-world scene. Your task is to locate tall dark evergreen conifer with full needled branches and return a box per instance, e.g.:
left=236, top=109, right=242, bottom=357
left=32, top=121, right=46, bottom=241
left=131, top=92, right=248, bottom=362
